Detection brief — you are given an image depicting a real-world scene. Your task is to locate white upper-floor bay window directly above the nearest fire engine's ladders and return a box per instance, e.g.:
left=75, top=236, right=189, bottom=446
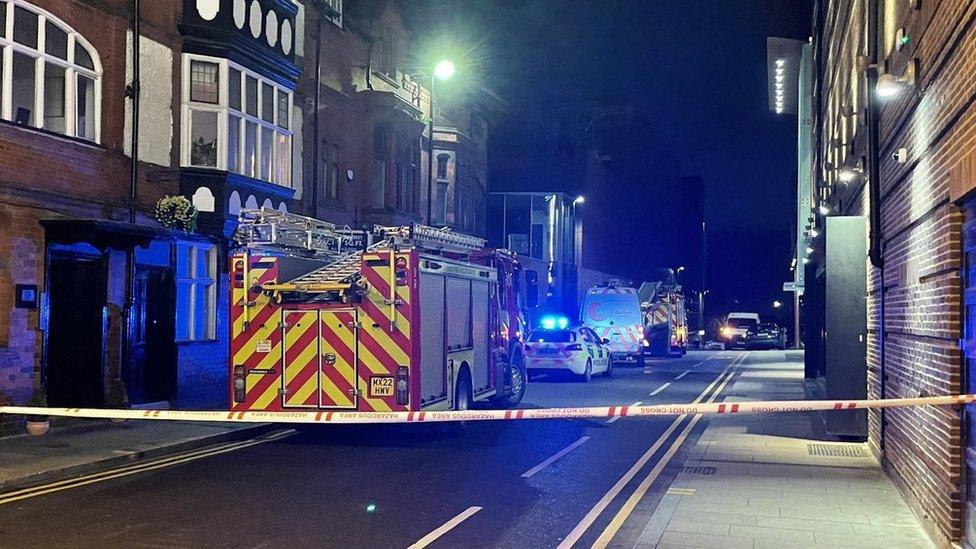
left=181, top=54, right=293, bottom=187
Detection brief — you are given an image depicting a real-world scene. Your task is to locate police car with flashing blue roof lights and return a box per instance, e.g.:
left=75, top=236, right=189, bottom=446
left=525, top=317, right=613, bottom=381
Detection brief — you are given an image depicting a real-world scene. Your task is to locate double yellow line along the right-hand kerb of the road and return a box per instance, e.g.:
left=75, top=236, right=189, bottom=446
left=559, top=353, right=748, bottom=549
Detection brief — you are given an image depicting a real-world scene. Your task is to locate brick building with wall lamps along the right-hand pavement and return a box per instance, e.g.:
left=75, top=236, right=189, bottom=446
left=796, top=0, right=976, bottom=546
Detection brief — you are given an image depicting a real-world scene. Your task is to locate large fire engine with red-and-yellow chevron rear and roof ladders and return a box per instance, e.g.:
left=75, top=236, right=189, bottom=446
left=229, top=208, right=527, bottom=412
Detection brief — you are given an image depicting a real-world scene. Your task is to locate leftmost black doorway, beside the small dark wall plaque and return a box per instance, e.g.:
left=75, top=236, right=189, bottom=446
left=47, top=254, right=107, bottom=408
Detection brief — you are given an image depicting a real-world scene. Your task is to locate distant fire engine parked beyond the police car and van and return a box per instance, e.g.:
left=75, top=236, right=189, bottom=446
left=637, top=282, right=688, bottom=356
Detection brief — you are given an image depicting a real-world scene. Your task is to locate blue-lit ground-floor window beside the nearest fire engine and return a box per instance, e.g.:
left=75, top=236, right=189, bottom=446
left=176, top=242, right=217, bottom=341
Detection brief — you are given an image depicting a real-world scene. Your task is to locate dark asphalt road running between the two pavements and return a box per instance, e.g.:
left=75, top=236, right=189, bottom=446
left=0, top=351, right=749, bottom=548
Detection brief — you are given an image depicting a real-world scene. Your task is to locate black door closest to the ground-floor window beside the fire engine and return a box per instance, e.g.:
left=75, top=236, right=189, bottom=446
left=126, top=267, right=176, bottom=404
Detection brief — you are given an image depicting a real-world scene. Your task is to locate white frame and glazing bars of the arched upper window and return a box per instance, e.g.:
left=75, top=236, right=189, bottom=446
left=0, top=0, right=102, bottom=144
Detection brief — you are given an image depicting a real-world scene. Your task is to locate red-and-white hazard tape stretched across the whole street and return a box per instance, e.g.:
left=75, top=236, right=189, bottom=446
left=0, top=395, right=976, bottom=424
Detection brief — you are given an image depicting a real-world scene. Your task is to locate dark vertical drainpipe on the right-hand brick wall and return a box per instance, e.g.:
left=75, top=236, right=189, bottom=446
left=865, top=0, right=887, bottom=446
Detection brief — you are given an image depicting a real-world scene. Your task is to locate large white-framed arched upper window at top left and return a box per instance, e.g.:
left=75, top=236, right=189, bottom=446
left=0, top=0, right=102, bottom=142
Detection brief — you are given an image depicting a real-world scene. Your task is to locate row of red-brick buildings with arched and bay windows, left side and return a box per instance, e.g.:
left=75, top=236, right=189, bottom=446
left=0, top=0, right=500, bottom=430
